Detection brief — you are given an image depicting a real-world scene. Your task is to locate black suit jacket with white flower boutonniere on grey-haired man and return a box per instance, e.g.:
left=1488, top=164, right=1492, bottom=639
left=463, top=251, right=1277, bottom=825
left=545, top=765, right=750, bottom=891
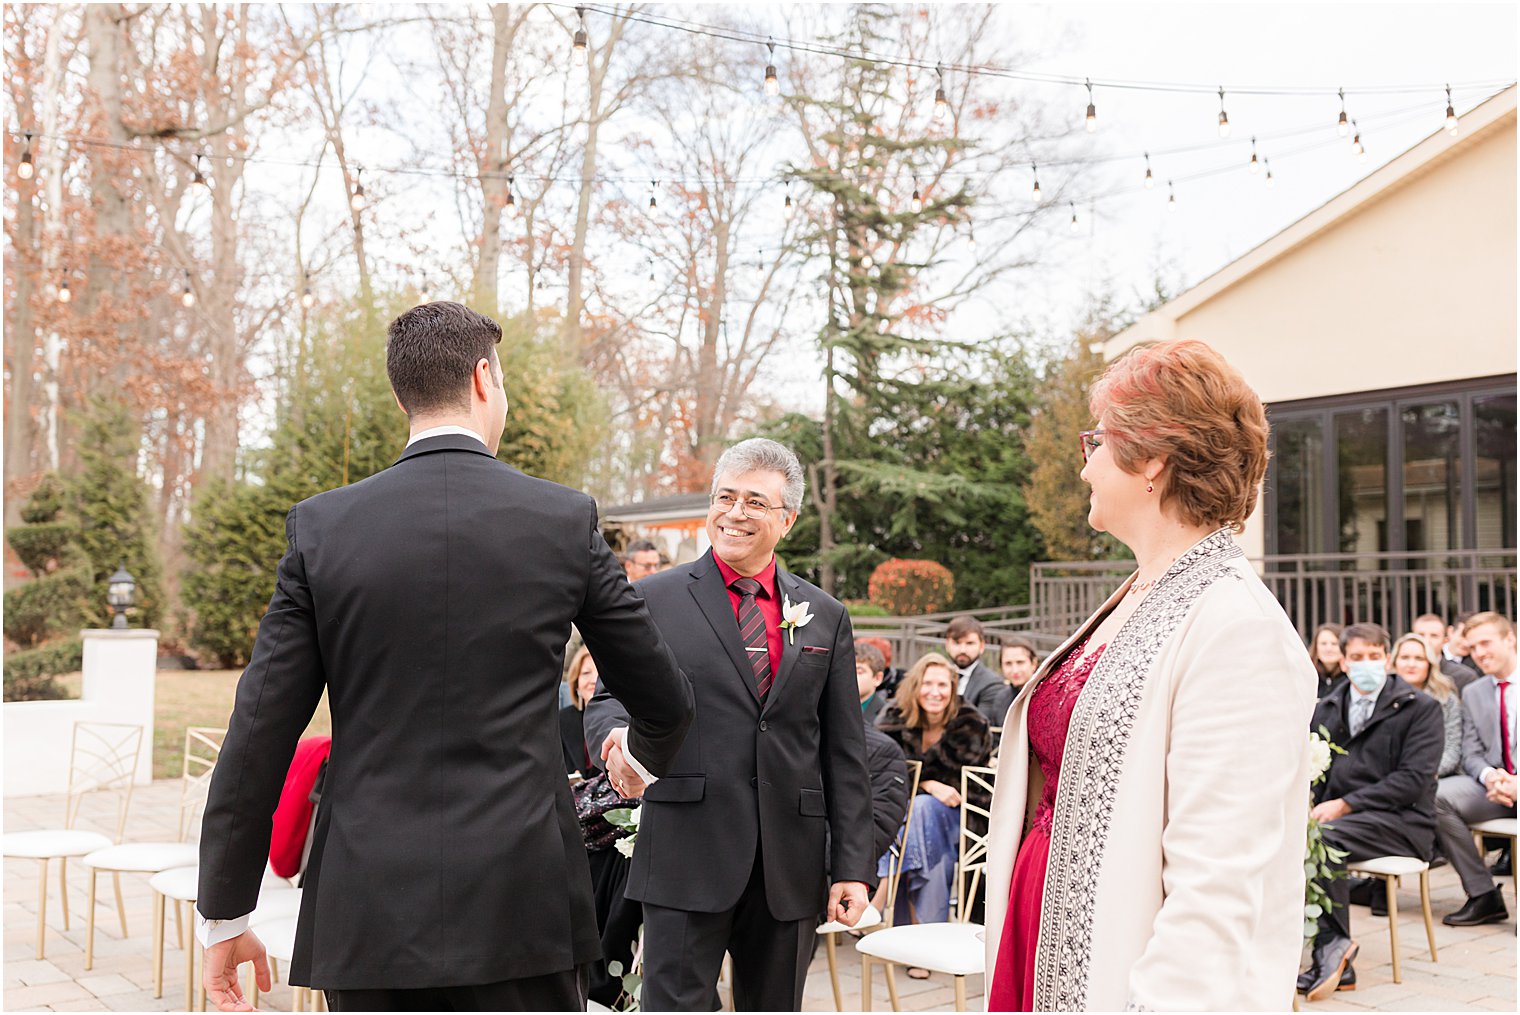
left=585, top=552, right=876, bottom=921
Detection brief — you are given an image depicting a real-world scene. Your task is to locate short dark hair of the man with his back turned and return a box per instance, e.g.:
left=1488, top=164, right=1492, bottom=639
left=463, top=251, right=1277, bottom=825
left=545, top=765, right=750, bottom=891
left=385, top=302, right=502, bottom=416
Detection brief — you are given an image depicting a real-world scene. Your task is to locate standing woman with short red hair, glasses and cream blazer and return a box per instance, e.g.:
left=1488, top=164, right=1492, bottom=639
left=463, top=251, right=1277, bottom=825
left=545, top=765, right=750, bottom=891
left=985, top=342, right=1315, bottom=1010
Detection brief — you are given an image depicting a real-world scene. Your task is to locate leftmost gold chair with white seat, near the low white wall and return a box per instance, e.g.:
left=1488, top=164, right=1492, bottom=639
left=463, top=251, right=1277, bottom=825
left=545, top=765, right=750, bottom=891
left=0, top=722, right=143, bottom=959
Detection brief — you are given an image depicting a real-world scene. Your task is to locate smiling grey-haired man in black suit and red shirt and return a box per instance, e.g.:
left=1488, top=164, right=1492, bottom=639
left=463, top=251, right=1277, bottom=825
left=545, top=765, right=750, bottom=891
left=585, top=438, right=876, bottom=1012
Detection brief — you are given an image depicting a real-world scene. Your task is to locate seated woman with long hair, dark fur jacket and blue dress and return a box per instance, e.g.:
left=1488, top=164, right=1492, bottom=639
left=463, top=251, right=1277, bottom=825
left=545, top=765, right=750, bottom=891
left=877, top=652, right=1002, bottom=935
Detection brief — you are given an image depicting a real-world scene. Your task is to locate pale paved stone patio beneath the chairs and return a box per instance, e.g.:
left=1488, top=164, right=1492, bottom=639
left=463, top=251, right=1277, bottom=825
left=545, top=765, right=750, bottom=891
left=3, top=779, right=1515, bottom=1012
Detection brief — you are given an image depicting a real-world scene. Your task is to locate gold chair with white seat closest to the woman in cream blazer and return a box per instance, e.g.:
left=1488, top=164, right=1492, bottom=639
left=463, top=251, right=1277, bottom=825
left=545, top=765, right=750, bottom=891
left=856, top=766, right=997, bottom=1012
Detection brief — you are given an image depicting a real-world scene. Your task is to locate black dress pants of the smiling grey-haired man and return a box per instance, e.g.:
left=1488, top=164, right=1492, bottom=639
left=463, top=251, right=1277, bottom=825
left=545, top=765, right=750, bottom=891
left=643, top=849, right=822, bottom=1012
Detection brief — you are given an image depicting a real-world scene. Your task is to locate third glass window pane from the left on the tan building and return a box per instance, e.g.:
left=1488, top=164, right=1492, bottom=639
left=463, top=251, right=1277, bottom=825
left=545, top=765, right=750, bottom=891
left=1398, top=401, right=1462, bottom=550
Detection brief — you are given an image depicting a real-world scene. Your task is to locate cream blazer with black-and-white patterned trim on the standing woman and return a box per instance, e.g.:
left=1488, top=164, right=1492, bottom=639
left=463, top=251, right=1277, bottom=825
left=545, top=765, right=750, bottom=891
left=985, top=529, right=1316, bottom=1010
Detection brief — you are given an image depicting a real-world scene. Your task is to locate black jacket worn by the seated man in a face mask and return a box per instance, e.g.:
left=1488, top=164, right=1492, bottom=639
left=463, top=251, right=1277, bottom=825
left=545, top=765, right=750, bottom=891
left=1309, top=673, right=1446, bottom=860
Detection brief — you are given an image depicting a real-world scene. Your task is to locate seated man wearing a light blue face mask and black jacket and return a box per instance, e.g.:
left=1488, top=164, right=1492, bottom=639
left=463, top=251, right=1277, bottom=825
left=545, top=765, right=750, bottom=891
left=1298, top=624, right=1441, bottom=1001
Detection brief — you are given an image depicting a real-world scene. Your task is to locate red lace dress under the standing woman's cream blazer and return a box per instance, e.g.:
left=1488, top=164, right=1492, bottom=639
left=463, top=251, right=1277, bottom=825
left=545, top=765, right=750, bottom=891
left=986, top=641, right=1105, bottom=1012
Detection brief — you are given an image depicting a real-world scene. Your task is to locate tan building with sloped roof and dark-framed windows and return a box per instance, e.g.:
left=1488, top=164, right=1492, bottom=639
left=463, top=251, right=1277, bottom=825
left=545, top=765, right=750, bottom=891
left=1104, top=87, right=1517, bottom=586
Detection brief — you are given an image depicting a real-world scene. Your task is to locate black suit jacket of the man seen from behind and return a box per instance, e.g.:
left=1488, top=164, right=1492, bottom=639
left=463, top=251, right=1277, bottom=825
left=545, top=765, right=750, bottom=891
left=199, top=436, right=692, bottom=989
